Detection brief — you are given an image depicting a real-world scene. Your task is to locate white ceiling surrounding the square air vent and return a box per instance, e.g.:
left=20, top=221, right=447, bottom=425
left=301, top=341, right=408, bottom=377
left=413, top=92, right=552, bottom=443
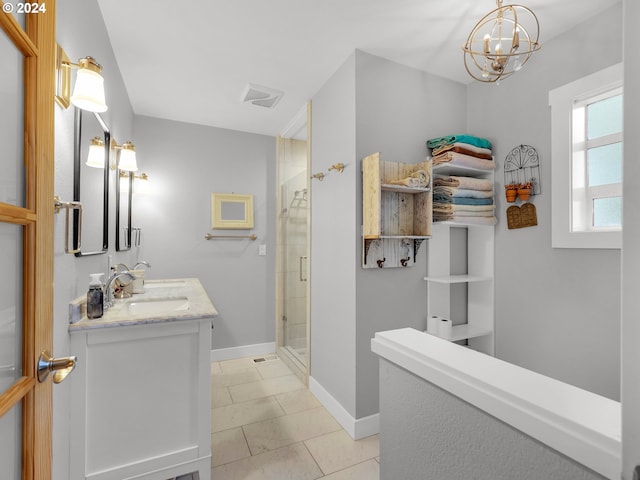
left=98, top=0, right=621, bottom=136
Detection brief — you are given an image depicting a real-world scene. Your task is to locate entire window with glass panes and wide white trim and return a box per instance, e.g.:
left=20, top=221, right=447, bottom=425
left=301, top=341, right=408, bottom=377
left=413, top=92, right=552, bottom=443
left=549, top=64, right=623, bottom=248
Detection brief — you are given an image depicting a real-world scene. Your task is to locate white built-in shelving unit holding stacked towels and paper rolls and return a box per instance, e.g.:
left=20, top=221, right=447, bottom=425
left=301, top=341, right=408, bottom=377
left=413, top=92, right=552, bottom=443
left=425, top=165, right=495, bottom=355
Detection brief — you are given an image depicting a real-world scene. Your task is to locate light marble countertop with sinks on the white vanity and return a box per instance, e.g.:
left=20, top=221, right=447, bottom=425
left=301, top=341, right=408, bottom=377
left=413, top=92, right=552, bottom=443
left=69, top=278, right=218, bottom=333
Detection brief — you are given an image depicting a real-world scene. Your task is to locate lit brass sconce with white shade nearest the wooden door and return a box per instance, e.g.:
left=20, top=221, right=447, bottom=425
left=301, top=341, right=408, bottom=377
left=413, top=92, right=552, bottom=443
left=56, top=45, right=107, bottom=112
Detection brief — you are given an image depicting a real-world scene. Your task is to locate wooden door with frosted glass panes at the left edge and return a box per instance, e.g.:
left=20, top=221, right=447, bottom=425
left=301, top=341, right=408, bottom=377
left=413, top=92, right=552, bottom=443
left=0, top=0, right=55, bottom=480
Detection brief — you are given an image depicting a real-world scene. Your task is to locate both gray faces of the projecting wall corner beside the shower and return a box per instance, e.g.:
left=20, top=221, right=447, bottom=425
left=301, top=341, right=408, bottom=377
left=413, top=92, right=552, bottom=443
left=311, top=51, right=465, bottom=418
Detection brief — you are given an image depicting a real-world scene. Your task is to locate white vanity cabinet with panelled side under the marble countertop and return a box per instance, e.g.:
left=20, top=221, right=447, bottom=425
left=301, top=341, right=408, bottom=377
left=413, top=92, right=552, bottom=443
left=69, top=280, right=217, bottom=480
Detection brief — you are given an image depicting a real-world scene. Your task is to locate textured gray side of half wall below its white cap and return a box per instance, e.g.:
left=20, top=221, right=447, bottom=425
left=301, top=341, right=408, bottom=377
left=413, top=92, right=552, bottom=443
left=380, top=358, right=604, bottom=480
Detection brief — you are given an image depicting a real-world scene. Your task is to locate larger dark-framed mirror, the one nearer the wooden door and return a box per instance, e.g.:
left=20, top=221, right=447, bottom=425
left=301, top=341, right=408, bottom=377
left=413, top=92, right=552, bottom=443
left=73, top=108, right=111, bottom=257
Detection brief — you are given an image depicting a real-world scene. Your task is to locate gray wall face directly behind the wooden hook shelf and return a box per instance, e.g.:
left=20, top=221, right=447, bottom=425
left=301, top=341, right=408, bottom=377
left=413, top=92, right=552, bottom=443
left=352, top=51, right=466, bottom=418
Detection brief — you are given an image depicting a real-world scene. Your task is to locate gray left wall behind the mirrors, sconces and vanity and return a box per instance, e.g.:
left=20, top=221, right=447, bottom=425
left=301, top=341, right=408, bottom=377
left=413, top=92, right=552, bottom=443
left=53, top=0, right=135, bottom=479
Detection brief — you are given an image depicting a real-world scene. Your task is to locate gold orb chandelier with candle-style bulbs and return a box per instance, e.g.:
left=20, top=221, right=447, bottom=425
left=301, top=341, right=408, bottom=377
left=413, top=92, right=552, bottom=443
left=462, top=0, right=540, bottom=83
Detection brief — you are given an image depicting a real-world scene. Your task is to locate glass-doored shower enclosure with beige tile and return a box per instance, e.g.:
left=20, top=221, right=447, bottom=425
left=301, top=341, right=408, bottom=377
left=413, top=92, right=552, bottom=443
left=276, top=105, right=310, bottom=384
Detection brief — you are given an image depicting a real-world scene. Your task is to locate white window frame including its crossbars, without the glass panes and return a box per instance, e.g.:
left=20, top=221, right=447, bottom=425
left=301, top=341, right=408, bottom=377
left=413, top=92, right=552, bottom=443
left=549, top=63, right=624, bottom=249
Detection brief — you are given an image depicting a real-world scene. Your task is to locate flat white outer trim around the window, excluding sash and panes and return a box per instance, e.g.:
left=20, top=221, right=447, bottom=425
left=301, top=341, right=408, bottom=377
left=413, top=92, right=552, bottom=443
left=549, top=63, right=623, bottom=248
